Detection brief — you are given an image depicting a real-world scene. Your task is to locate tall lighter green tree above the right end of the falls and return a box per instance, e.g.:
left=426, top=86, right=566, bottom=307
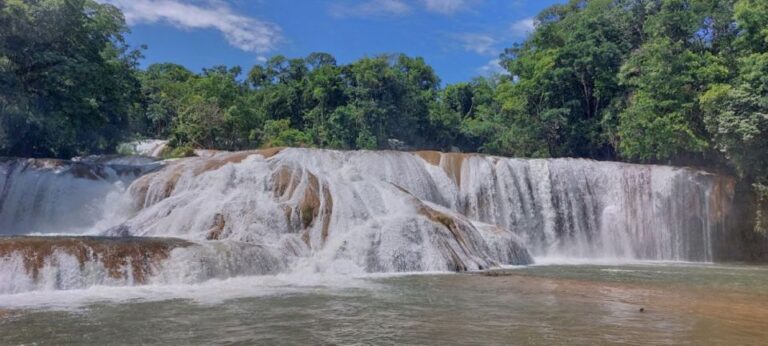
left=619, top=0, right=730, bottom=160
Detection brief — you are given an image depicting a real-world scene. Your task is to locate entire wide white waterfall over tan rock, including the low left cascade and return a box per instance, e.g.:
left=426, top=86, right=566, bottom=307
left=0, top=148, right=734, bottom=293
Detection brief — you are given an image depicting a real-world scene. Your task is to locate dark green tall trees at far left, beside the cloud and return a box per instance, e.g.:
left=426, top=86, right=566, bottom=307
left=0, top=0, right=141, bottom=157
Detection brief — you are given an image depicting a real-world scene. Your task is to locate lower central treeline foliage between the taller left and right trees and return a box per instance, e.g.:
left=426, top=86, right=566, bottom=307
left=141, top=53, right=439, bottom=149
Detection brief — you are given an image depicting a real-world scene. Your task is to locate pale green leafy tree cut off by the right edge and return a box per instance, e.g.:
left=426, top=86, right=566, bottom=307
left=700, top=0, right=768, bottom=234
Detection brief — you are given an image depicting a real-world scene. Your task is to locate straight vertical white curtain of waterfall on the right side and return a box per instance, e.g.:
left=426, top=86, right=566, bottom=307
left=446, top=154, right=734, bottom=262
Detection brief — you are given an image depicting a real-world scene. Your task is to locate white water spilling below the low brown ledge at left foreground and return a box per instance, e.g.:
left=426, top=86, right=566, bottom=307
left=0, top=242, right=285, bottom=294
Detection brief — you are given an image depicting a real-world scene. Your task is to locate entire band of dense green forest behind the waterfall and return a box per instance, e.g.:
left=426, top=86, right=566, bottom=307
left=0, top=0, right=768, bottom=230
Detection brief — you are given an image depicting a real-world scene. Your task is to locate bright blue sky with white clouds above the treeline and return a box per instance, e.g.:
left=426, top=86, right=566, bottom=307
left=99, top=0, right=563, bottom=83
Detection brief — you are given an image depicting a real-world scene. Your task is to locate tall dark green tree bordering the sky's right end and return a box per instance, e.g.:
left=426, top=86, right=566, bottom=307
left=495, top=0, right=640, bottom=158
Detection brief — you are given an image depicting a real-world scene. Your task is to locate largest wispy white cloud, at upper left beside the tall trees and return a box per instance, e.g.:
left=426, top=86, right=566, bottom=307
left=99, top=0, right=282, bottom=53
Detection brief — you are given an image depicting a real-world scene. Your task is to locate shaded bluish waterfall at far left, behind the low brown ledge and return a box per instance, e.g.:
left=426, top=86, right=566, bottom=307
left=0, top=158, right=159, bottom=235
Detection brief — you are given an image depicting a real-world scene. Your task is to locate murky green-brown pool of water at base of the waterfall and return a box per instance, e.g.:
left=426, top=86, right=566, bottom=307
left=0, top=261, right=768, bottom=345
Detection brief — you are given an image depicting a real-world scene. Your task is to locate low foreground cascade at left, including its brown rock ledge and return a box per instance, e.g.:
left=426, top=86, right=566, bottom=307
left=0, top=236, right=285, bottom=294
